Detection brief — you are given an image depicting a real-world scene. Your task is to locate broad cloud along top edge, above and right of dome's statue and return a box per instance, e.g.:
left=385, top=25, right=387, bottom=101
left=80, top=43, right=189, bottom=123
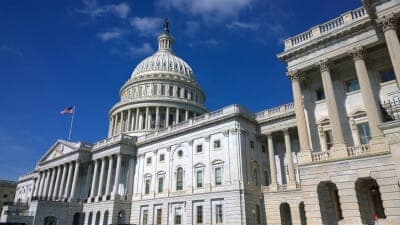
left=156, top=0, right=253, bottom=20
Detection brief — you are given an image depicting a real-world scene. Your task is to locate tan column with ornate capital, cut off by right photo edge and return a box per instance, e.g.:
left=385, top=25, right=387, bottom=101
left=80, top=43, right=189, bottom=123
left=381, top=16, right=400, bottom=86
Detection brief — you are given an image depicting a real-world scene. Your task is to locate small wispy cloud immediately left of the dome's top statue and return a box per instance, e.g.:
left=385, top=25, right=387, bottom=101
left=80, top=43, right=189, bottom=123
left=130, top=17, right=163, bottom=36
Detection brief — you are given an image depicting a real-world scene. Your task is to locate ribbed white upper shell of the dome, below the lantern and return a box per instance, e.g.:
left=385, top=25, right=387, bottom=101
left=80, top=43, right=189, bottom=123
left=132, top=50, right=194, bottom=79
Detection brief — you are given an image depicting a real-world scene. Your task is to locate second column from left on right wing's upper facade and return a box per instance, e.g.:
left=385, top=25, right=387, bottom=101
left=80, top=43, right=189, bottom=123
left=317, top=59, right=345, bottom=149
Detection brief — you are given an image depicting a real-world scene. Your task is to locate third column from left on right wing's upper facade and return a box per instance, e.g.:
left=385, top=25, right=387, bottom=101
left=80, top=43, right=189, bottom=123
left=350, top=47, right=382, bottom=138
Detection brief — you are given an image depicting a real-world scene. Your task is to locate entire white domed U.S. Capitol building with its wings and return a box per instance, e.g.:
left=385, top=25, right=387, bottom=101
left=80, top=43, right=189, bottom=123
left=0, top=0, right=400, bottom=225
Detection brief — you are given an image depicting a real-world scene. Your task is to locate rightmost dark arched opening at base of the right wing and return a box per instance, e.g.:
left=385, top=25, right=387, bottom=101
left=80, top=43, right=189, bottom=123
left=355, top=177, right=386, bottom=224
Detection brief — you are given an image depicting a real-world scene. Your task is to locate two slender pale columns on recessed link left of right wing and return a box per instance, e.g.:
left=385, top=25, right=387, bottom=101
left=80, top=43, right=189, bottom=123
left=267, top=128, right=296, bottom=189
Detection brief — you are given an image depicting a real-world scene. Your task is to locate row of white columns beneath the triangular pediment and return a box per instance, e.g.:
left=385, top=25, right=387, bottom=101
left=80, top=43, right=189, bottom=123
left=34, top=160, right=80, bottom=201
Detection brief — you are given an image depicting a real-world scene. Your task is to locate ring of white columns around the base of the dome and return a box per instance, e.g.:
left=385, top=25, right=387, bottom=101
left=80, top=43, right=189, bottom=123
left=108, top=106, right=197, bottom=136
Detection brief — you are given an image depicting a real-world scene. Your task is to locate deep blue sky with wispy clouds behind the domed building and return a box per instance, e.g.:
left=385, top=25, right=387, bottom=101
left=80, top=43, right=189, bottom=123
left=0, top=0, right=361, bottom=179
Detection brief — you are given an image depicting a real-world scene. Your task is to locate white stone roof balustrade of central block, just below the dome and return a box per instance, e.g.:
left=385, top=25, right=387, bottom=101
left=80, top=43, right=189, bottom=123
left=138, top=105, right=254, bottom=142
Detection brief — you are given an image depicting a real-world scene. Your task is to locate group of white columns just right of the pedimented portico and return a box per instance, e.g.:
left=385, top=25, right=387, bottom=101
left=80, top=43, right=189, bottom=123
left=89, top=154, right=122, bottom=200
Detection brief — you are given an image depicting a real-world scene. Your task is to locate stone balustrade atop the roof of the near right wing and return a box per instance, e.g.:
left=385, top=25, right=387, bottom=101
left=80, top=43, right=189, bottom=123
left=285, top=7, right=368, bottom=51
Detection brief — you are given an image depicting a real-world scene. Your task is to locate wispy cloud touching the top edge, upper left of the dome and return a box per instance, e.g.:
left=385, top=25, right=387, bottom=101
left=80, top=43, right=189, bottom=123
left=77, top=0, right=131, bottom=19
